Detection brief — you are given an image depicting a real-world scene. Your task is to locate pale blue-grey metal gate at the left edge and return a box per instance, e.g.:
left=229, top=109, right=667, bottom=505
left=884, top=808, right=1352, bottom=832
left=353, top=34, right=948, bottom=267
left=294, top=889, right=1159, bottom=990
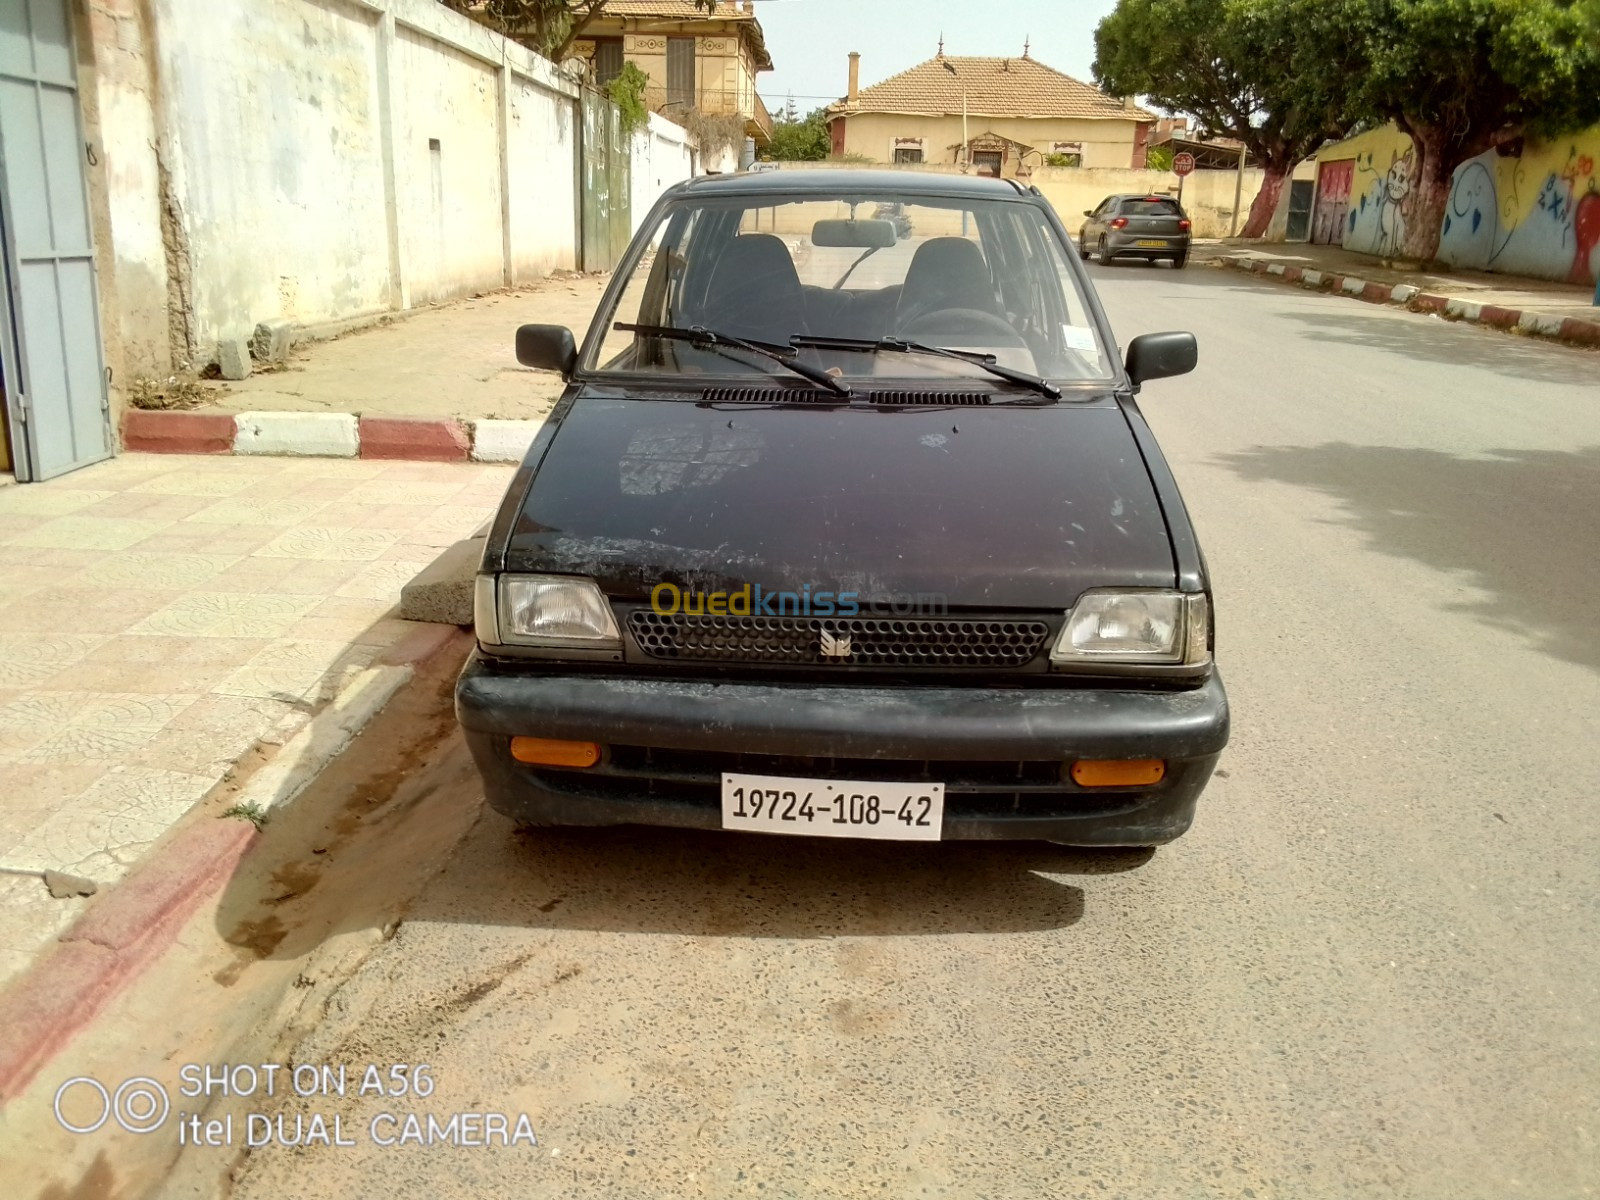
left=0, top=0, right=112, bottom=480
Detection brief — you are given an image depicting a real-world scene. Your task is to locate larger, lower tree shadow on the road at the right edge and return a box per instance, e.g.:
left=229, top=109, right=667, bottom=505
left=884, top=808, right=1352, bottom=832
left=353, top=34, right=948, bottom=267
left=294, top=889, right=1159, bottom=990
left=1218, top=442, right=1600, bottom=670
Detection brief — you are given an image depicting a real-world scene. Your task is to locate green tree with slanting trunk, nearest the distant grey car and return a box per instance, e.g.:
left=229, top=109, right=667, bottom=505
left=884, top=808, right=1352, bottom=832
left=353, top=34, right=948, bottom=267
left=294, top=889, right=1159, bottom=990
left=1094, top=0, right=1352, bottom=237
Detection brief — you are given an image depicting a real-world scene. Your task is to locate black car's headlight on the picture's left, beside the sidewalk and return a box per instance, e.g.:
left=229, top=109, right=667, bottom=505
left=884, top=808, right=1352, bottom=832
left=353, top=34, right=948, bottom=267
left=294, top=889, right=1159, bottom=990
left=474, top=574, right=622, bottom=650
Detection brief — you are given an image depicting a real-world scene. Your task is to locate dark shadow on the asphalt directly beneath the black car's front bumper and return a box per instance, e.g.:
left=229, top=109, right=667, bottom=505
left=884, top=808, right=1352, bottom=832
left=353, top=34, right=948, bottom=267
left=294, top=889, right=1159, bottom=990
left=400, top=811, right=1152, bottom=938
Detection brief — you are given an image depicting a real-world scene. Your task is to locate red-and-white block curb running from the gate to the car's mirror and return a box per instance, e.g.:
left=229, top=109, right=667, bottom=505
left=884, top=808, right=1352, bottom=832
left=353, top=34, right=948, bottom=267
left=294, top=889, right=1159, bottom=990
left=122, top=408, right=544, bottom=462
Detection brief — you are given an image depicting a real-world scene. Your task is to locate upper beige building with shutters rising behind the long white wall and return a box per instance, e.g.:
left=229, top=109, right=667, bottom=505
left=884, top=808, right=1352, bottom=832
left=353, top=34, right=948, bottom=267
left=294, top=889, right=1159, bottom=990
left=573, top=0, right=773, bottom=146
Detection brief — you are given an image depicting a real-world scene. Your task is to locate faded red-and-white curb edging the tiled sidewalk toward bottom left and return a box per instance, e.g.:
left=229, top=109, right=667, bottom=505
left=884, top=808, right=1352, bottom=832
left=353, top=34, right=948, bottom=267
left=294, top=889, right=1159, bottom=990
left=0, top=630, right=462, bottom=1106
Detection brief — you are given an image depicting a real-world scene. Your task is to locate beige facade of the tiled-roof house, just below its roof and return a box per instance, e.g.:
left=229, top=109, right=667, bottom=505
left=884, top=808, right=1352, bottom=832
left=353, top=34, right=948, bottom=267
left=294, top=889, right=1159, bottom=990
left=842, top=112, right=1138, bottom=176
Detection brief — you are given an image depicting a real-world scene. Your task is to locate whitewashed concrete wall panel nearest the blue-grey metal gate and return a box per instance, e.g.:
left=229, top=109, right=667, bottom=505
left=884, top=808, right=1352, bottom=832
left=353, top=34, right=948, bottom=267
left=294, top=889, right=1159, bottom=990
left=154, top=0, right=389, bottom=339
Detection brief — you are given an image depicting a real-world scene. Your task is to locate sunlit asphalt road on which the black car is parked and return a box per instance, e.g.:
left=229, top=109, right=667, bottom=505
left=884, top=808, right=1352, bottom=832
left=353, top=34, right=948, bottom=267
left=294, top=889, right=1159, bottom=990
left=219, top=266, right=1600, bottom=1200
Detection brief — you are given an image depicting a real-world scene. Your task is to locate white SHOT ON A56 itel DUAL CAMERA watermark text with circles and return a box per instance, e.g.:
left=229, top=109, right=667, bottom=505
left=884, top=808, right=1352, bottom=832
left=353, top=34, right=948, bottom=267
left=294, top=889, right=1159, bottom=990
left=54, top=1062, right=539, bottom=1149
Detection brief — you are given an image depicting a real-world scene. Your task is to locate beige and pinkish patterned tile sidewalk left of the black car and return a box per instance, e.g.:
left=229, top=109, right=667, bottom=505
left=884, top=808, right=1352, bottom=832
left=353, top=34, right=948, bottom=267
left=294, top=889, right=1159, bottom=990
left=0, top=454, right=510, bottom=982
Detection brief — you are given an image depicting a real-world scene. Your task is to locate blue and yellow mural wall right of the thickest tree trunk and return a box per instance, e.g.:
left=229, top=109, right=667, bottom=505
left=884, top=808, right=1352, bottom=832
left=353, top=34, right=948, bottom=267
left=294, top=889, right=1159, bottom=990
left=1438, top=128, right=1600, bottom=283
